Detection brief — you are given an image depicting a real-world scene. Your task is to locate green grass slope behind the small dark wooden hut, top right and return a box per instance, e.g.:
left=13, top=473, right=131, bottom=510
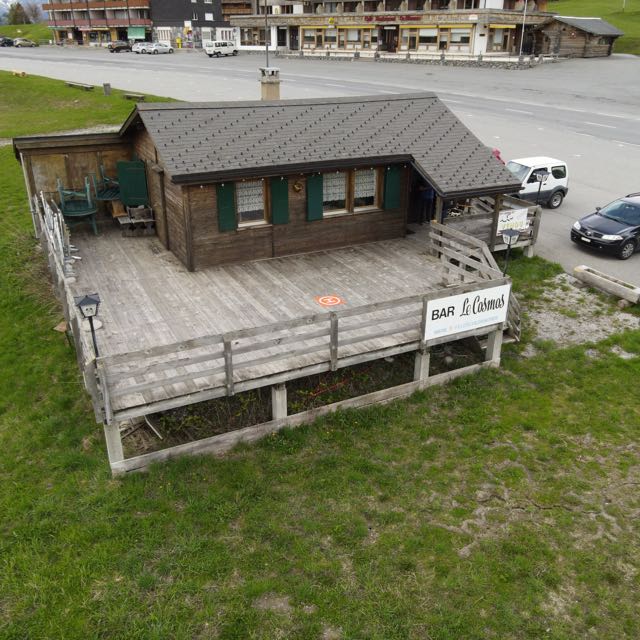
left=548, top=0, right=640, bottom=55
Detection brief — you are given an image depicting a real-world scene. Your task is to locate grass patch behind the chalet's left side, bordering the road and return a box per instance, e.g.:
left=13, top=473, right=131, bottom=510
left=0, top=71, right=170, bottom=138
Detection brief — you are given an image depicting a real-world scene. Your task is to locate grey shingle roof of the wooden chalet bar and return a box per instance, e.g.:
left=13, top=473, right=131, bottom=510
left=122, top=93, right=519, bottom=196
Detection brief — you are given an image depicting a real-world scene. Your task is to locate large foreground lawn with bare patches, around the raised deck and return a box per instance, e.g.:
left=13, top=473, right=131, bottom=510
left=0, top=74, right=640, bottom=640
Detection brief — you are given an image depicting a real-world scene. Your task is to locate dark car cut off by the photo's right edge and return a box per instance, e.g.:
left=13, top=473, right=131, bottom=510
left=571, top=193, right=640, bottom=260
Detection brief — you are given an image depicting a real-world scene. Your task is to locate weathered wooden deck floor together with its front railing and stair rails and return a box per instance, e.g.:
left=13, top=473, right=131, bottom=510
left=63, top=222, right=501, bottom=422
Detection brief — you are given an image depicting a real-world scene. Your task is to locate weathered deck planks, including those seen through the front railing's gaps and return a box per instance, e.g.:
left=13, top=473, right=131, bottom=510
left=71, top=227, right=478, bottom=413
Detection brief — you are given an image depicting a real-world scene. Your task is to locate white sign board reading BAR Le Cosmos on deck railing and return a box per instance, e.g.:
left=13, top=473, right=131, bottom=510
left=424, top=284, right=511, bottom=340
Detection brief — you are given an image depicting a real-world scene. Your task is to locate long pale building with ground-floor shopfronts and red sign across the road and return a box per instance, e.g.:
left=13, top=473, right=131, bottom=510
left=231, top=0, right=551, bottom=55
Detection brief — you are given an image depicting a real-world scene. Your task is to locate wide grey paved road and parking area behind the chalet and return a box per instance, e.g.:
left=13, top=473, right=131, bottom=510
left=0, top=47, right=640, bottom=284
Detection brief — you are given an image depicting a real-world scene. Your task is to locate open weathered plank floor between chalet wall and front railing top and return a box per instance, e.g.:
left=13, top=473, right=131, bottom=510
left=71, top=226, right=442, bottom=355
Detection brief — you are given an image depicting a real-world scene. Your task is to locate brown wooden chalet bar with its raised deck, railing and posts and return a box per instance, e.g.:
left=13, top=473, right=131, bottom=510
left=14, top=93, right=539, bottom=473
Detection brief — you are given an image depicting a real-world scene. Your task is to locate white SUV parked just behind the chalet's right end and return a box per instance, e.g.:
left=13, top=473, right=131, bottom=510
left=507, top=156, right=569, bottom=209
